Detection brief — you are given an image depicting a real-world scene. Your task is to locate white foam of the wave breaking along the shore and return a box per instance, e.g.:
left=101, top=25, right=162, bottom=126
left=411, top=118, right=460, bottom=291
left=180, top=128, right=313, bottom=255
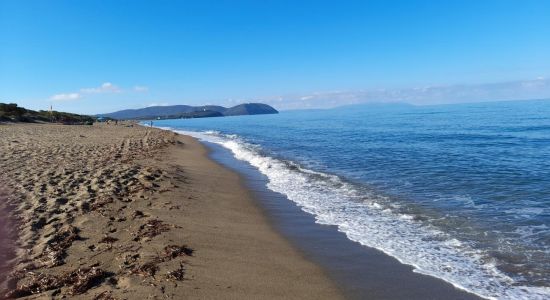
left=166, top=127, right=550, bottom=299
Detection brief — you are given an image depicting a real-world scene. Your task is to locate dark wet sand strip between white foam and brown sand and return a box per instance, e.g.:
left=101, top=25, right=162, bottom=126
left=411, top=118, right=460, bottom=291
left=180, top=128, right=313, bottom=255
left=190, top=137, right=484, bottom=299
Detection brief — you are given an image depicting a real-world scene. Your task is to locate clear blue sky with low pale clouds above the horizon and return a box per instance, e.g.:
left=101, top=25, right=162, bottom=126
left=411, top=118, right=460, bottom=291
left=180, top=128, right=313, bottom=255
left=0, top=0, right=550, bottom=113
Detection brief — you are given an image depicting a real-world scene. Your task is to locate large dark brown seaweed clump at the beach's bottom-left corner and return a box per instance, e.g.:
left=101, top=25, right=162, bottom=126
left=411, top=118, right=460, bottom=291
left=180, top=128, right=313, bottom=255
left=5, top=267, right=110, bottom=299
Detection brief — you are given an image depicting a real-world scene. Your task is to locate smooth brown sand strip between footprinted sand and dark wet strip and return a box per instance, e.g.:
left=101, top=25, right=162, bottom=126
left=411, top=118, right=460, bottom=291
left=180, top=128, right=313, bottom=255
left=156, top=131, right=341, bottom=299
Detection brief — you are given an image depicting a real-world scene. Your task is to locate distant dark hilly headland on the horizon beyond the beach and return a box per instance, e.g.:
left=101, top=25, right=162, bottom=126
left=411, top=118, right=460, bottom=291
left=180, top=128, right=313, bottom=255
left=98, top=103, right=279, bottom=120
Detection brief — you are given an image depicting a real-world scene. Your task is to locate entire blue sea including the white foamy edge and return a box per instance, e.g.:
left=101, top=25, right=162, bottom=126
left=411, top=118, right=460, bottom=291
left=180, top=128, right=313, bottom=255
left=149, top=100, right=550, bottom=299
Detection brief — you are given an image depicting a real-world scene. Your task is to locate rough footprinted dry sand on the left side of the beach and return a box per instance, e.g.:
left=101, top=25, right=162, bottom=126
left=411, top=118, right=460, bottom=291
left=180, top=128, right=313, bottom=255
left=0, top=124, right=191, bottom=299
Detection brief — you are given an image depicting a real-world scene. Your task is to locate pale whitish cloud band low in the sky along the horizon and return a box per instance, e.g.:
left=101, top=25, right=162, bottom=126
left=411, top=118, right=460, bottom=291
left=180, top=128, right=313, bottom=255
left=40, top=77, right=550, bottom=113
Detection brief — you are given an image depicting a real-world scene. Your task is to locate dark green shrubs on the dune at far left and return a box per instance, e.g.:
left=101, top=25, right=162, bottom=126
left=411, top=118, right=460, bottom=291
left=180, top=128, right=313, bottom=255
left=0, top=103, right=95, bottom=125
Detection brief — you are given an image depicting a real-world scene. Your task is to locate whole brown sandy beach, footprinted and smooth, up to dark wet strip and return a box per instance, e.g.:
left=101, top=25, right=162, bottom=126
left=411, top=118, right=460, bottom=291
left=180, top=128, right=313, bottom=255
left=0, top=124, right=341, bottom=299
